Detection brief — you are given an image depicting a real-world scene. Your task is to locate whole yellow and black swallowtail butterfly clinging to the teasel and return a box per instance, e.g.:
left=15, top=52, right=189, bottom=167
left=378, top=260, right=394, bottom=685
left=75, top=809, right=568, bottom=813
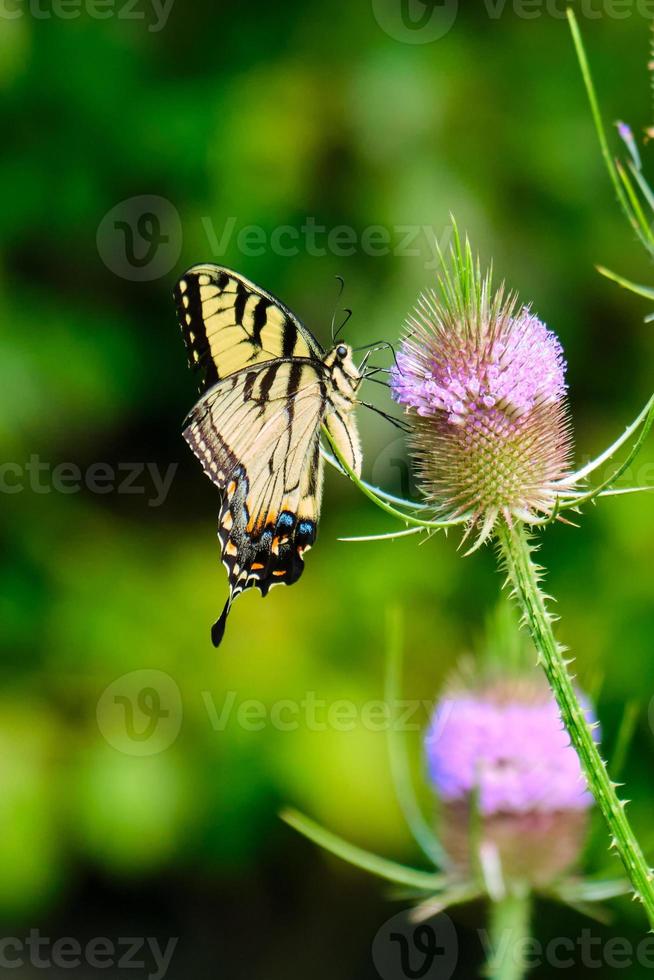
left=174, top=264, right=363, bottom=647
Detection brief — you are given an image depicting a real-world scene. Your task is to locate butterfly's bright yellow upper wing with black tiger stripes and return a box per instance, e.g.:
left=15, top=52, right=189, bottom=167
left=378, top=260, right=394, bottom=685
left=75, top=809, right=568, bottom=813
left=174, top=265, right=323, bottom=393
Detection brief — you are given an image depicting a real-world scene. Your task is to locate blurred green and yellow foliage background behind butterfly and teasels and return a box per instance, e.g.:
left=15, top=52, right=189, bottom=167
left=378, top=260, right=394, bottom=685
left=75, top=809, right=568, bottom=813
left=0, top=0, right=654, bottom=980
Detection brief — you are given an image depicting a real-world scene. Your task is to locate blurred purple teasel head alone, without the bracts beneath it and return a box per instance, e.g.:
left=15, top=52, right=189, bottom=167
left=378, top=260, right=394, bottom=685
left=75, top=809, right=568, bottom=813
left=425, top=673, right=593, bottom=884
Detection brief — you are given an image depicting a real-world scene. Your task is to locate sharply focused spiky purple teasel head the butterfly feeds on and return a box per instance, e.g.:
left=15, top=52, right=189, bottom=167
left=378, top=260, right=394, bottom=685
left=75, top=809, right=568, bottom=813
left=391, top=232, right=572, bottom=541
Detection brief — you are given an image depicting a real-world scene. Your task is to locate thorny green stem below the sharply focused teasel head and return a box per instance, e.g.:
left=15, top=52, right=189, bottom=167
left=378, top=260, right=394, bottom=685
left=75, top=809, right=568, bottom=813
left=498, top=524, right=654, bottom=929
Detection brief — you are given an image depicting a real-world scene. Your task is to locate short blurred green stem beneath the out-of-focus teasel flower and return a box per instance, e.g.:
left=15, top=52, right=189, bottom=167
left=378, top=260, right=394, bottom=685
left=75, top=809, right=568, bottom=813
left=484, top=889, right=531, bottom=980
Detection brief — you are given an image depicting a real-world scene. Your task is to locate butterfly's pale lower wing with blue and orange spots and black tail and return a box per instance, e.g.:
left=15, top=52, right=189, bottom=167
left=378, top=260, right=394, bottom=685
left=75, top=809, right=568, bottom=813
left=184, top=359, right=325, bottom=645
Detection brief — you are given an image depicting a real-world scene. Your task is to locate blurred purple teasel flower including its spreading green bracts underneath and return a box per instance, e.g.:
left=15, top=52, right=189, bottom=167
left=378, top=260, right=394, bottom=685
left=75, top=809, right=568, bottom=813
left=283, top=661, right=629, bottom=920
